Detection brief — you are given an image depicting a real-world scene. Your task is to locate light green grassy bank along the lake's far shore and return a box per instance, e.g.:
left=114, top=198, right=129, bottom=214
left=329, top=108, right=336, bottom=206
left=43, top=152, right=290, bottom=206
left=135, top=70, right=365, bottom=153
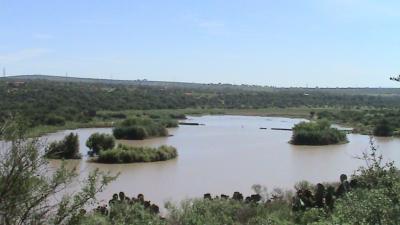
left=25, top=107, right=400, bottom=137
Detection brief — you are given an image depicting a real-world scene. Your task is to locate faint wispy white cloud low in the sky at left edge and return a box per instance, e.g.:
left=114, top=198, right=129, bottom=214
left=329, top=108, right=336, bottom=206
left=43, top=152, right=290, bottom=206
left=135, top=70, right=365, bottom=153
left=0, top=48, right=51, bottom=63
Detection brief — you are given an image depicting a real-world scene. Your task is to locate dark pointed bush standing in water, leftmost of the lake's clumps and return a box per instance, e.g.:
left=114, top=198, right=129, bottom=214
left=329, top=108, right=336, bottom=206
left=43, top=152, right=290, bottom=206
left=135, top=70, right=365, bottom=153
left=45, top=133, right=82, bottom=159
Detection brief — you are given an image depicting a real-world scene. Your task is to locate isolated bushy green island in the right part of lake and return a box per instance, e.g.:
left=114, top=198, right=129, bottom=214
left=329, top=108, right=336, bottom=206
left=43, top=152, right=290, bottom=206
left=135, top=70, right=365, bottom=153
left=290, top=120, right=348, bottom=145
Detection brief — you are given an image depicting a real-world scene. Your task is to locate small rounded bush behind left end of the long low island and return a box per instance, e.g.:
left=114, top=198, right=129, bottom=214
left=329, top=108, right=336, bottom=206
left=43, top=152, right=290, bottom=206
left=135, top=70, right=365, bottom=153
left=86, top=133, right=115, bottom=155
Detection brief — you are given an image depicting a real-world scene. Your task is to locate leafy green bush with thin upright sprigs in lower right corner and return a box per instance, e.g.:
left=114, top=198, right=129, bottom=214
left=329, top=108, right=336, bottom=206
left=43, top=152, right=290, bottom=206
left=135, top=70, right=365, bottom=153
left=332, top=138, right=400, bottom=224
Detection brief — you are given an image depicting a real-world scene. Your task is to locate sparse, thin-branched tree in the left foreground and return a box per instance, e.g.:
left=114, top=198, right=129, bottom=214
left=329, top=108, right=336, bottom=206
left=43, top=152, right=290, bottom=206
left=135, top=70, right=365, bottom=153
left=0, top=118, right=116, bottom=225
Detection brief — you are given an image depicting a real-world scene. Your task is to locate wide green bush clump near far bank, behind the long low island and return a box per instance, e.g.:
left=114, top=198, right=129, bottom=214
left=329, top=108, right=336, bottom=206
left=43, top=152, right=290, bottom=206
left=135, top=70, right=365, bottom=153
left=113, top=117, right=171, bottom=140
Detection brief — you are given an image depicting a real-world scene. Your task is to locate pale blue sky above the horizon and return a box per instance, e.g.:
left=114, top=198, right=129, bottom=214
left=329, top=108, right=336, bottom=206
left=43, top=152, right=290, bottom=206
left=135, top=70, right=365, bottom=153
left=0, top=0, right=400, bottom=87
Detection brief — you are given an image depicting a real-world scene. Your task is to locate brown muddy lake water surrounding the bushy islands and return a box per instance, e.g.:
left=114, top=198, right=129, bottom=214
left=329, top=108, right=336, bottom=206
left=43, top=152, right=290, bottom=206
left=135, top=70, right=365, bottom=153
left=44, top=116, right=400, bottom=206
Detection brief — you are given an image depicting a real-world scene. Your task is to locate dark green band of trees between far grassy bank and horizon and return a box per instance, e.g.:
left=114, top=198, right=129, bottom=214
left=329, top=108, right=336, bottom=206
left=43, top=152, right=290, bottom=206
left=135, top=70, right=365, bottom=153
left=0, top=79, right=400, bottom=127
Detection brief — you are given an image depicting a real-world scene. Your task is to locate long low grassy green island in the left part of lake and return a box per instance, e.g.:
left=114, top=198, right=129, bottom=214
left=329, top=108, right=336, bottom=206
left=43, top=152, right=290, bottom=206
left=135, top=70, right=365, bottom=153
left=96, top=144, right=178, bottom=163
